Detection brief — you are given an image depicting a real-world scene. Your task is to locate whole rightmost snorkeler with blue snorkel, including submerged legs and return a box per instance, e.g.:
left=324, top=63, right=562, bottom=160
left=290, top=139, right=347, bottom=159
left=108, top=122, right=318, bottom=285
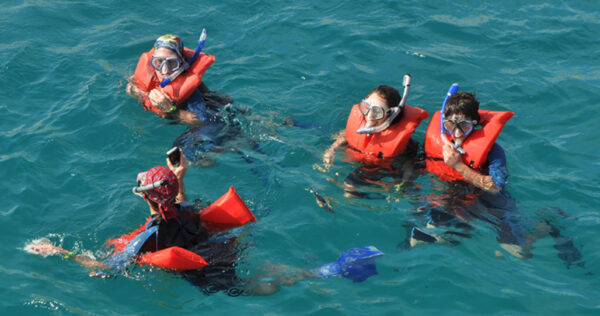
left=408, top=84, right=581, bottom=267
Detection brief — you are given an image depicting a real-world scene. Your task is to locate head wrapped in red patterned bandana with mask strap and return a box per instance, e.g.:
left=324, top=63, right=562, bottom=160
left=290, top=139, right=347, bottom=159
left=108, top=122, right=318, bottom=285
left=137, top=166, right=179, bottom=219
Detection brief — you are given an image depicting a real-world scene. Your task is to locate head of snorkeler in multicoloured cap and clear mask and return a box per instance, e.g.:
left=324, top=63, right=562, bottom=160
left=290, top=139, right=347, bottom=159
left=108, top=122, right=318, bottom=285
left=150, top=34, right=185, bottom=80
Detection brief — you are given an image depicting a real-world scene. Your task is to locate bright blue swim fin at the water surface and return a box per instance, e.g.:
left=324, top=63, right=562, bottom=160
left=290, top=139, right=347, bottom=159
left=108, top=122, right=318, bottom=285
left=311, top=246, right=383, bottom=282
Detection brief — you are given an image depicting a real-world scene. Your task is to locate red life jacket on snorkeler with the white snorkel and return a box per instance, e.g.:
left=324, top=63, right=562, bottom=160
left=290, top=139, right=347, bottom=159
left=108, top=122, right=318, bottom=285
left=346, top=104, right=429, bottom=165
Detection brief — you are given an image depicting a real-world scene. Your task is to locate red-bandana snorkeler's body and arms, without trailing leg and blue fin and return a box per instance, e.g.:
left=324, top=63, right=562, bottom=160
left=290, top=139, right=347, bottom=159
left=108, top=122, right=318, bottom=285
left=29, top=154, right=256, bottom=292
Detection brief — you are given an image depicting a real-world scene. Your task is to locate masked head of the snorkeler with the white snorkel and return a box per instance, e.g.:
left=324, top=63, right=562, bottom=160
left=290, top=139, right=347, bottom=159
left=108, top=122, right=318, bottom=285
left=359, top=85, right=402, bottom=127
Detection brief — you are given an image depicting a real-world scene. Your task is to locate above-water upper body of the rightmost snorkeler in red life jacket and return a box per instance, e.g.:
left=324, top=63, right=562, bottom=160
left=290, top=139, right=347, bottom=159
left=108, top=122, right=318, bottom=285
left=425, top=85, right=513, bottom=193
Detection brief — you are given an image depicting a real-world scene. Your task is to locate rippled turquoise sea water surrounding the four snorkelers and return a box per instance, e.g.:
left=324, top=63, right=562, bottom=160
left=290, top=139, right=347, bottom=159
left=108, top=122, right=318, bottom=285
left=0, top=0, right=600, bottom=315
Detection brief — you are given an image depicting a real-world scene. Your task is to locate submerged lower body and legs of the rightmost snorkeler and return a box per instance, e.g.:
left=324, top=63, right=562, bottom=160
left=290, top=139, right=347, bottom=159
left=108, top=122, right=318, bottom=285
left=398, top=181, right=585, bottom=268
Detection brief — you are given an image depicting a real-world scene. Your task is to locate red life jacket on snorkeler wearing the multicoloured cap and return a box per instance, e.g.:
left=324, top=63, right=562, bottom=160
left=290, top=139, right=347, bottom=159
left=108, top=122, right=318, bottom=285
left=133, top=48, right=215, bottom=117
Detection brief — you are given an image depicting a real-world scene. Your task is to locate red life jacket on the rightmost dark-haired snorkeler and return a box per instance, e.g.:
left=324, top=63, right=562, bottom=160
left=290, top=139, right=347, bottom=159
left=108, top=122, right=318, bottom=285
left=425, top=110, right=514, bottom=181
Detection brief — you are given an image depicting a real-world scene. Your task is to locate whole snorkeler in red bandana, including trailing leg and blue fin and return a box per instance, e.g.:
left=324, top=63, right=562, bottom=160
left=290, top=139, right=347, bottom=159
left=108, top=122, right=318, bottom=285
left=27, top=154, right=383, bottom=296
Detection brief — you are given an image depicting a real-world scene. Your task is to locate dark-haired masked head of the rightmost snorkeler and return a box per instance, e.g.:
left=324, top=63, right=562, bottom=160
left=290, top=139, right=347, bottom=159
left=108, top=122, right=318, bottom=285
left=443, top=91, right=480, bottom=143
